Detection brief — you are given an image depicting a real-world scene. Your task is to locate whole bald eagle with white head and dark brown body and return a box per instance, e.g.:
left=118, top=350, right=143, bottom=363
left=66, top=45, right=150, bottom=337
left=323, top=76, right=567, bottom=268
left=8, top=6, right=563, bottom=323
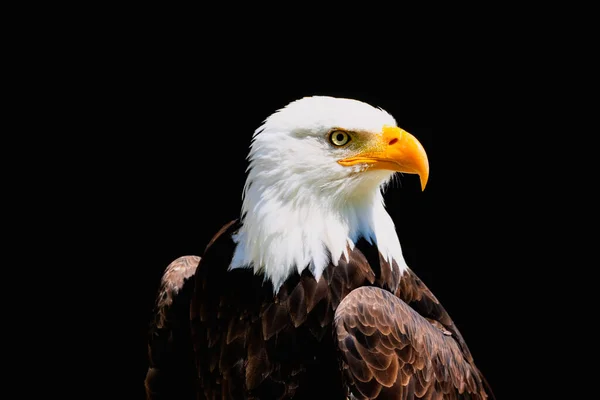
left=145, top=96, right=493, bottom=400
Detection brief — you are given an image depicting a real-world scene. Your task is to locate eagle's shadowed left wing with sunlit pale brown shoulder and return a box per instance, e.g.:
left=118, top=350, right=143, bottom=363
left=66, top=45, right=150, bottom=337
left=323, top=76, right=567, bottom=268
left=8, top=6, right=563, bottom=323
left=144, top=256, right=200, bottom=400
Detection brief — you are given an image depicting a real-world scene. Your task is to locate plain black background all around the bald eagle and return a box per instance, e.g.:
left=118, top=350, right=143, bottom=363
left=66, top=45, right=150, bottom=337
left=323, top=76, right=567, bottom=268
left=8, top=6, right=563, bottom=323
left=15, top=3, right=568, bottom=399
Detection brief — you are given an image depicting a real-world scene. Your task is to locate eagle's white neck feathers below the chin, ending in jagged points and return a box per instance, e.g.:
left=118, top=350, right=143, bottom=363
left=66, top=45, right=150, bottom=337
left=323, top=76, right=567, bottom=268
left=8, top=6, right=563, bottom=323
left=230, top=167, right=407, bottom=291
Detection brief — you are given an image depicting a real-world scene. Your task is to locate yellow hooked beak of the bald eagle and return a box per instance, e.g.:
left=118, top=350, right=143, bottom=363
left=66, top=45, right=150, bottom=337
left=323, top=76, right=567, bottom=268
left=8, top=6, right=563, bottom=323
left=338, top=125, right=429, bottom=190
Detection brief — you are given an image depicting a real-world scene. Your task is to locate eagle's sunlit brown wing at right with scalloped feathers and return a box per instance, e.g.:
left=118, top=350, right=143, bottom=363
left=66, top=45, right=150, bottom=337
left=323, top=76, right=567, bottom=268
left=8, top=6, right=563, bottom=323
left=334, top=282, right=487, bottom=400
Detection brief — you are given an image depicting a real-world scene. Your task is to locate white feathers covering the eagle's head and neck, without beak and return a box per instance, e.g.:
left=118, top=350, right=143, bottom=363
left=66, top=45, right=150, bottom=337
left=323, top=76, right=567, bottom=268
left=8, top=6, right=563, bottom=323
left=230, top=96, right=406, bottom=291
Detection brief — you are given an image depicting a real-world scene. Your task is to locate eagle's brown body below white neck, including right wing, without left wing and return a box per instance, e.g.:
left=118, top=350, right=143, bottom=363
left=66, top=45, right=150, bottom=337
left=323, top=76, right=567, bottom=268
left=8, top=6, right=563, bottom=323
left=146, top=221, right=487, bottom=400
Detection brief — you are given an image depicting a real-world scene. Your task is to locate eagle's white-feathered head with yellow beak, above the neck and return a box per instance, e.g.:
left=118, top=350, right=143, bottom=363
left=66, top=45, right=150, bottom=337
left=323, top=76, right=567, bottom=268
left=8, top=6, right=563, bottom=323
left=249, top=96, right=429, bottom=201
